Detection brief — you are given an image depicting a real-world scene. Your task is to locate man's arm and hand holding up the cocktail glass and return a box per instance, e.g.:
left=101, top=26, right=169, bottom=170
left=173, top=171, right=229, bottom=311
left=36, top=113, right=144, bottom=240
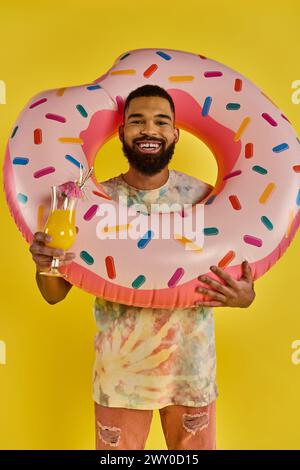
left=29, top=232, right=75, bottom=305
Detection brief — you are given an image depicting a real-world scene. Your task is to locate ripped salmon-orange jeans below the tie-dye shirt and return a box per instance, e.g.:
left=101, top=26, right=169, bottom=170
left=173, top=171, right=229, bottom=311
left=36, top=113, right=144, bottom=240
left=95, top=401, right=216, bottom=450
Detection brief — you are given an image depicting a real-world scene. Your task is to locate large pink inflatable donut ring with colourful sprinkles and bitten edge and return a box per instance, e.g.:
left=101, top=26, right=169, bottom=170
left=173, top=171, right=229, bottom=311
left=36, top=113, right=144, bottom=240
left=4, top=49, right=300, bottom=309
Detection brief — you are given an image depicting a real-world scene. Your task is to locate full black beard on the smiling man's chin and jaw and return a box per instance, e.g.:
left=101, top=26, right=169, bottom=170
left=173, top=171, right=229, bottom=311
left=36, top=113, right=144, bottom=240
left=122, top=139, right=176, bottom=176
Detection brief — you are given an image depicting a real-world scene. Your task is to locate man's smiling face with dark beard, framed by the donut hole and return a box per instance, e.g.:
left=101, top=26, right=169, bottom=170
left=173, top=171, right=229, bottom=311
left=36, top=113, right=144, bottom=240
left=119, top=96, right=179, bottom=175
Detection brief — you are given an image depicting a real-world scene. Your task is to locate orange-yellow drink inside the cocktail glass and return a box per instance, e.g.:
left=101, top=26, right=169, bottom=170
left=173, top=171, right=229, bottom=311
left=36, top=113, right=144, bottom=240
left=44, top=209, right=76, bottom=250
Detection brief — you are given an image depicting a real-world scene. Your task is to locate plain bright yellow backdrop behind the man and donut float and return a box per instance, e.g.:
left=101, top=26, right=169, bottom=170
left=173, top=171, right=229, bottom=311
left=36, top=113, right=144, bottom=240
left=0, top=0, right=300, bottom=449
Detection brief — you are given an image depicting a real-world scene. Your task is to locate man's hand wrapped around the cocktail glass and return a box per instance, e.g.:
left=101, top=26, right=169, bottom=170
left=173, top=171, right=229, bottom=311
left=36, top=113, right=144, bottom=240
left=29, top=232, right=75, bottom=271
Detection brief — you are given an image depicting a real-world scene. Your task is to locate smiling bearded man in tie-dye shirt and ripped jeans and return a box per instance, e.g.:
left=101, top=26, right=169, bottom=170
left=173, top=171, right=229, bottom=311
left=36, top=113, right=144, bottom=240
left=30, top=85, right=255, bottom=450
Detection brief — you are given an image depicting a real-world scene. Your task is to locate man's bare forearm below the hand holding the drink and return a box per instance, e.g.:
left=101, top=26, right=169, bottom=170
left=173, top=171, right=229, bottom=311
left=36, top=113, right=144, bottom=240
left=35, top=271, right=72, bottom=304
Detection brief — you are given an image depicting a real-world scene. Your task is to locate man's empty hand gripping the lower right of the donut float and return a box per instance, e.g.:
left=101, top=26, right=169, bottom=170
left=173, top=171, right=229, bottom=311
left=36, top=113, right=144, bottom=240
left=194, top=261, right=255, bottom=308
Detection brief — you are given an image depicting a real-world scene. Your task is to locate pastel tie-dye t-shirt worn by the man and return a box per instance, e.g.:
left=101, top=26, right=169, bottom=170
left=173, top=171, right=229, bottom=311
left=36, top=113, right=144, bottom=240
left=93, top=170, right=218, bottom=410
